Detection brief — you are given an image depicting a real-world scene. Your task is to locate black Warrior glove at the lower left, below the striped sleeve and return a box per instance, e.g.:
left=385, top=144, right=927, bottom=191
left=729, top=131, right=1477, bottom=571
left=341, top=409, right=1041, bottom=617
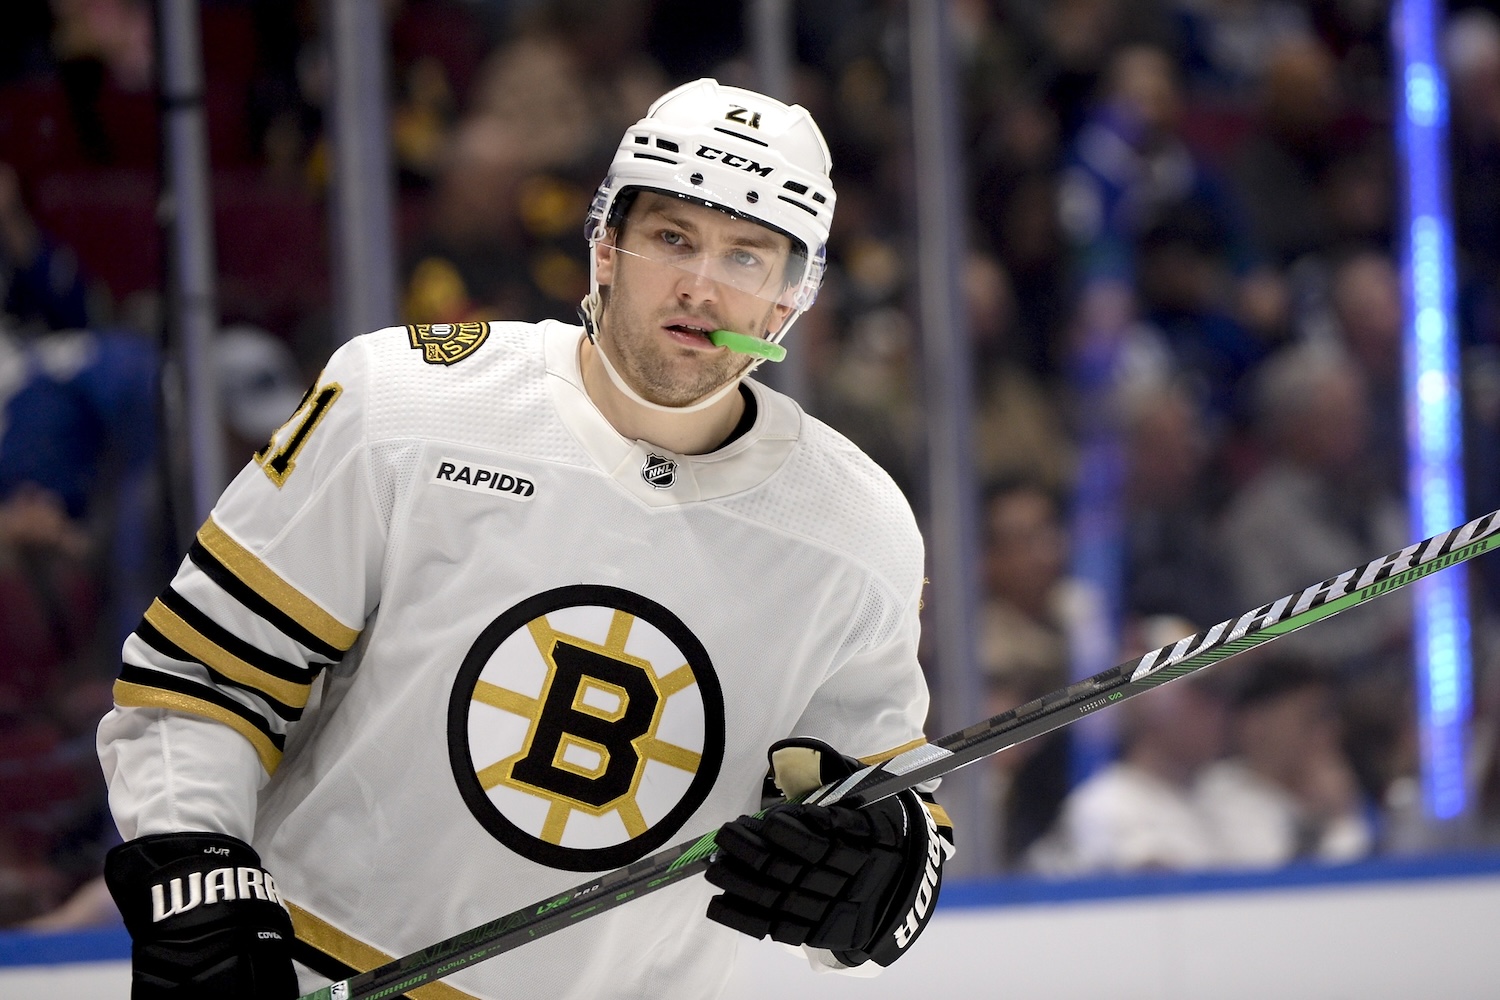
left=104, top=834, right=299, bottom=1000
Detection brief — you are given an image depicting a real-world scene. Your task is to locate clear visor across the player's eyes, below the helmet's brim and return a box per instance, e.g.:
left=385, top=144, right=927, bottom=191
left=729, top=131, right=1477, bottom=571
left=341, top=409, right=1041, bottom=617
left=597, top=234, right=807, bottom=309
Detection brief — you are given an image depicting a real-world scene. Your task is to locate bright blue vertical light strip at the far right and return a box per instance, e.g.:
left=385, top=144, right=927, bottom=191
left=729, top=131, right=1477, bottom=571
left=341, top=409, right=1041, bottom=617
left=1391, top=0, right=1472, bottom=820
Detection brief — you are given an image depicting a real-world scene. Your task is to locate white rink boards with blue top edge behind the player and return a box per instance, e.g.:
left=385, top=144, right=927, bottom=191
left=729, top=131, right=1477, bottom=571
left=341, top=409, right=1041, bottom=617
left=0, top=855, right=1500, bottom=1000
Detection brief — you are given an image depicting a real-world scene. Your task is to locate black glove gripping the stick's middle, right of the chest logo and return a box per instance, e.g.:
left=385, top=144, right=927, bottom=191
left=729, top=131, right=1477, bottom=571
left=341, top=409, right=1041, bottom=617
left=707, top=739, right=951, bottom=966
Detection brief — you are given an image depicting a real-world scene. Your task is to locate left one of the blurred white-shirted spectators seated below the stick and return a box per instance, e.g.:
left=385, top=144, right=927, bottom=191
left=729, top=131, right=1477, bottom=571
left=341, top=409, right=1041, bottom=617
left=1028, top=659, right=1224, bottom=876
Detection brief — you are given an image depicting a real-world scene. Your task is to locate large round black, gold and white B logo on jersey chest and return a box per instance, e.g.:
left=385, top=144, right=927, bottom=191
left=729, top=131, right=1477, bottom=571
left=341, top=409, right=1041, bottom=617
left=449, top=586, right=725, bottom=871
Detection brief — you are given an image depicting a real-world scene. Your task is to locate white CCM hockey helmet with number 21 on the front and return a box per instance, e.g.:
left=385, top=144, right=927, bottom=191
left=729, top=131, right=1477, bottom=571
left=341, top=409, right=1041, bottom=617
left=585, top=79, right=834, bottom=342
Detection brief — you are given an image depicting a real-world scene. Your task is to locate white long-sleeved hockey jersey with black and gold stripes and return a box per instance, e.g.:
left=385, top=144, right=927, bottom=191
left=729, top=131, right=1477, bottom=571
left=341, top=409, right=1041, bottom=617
left=99, top=322, right=927, bottom=1000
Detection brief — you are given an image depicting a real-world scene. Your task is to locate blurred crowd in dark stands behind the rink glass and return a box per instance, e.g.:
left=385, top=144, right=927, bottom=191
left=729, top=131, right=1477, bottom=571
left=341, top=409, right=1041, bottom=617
left=0, top=0, right=1500, bottom=924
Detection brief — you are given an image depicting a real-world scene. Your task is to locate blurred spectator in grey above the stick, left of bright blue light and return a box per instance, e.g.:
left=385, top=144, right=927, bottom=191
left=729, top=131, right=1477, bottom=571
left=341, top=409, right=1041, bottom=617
left=1224, top=343, right=1410, bottom=676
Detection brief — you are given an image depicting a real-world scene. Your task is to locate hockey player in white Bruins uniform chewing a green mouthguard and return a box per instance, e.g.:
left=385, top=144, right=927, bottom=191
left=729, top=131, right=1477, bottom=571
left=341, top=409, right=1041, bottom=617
left=99, top=79, right=950, bottom=1000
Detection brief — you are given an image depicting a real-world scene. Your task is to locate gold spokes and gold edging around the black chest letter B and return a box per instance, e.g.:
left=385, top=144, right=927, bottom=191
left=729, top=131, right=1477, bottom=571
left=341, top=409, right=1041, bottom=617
left=473, top=609, right=704, bottom=846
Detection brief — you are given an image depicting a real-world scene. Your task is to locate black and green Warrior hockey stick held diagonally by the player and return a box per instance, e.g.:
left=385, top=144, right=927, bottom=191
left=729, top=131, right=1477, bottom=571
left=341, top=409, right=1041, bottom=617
left=300, top=511, right=1500, bottom=1000
